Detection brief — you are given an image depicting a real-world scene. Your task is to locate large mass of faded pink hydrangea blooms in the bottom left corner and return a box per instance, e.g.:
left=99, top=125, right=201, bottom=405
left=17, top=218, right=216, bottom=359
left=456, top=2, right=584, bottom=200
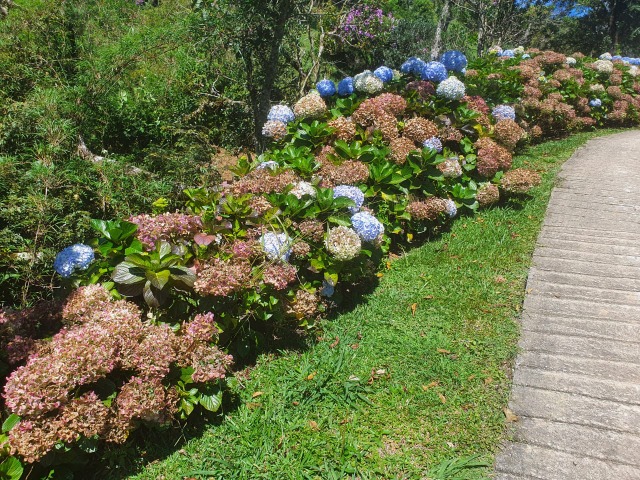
left=4, top=286, right=232, bottom=462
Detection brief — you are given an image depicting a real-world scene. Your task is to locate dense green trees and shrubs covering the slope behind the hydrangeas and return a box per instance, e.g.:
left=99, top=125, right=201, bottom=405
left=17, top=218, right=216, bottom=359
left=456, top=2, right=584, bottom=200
left=0, top=0, right=640, bottom=306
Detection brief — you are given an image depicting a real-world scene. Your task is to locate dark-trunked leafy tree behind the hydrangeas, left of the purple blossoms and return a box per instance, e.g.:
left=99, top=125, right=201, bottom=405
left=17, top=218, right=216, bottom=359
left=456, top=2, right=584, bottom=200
left=194, top=0, right=347, bottom=151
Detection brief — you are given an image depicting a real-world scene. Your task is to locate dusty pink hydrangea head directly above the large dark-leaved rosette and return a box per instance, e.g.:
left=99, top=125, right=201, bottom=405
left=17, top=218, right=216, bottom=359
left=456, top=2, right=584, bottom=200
left=129, top=212, right=202, bottom=250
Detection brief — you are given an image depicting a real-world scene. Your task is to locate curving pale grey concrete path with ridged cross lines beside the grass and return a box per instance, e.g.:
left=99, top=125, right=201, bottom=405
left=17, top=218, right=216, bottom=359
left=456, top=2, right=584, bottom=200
left=495, top=130, right=640, bottom=480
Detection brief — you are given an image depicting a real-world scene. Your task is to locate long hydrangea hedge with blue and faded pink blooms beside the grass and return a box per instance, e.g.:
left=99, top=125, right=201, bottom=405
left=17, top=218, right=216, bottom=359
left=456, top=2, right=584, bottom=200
left=5, top=46, right=640, bottom=468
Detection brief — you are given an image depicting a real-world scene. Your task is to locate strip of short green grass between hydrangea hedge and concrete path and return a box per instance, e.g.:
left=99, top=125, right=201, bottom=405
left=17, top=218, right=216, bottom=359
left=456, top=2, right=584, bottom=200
left=106, top=130, right=624, bottom=479
